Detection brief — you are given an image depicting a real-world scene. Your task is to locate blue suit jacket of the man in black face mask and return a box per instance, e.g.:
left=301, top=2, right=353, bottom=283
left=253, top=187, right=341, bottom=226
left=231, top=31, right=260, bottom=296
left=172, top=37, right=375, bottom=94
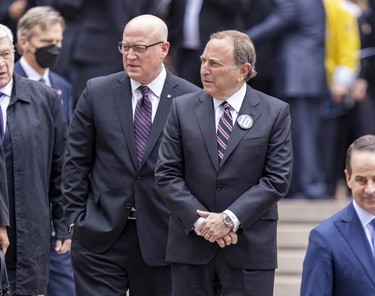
left=14, top=61, right=73, bottom=123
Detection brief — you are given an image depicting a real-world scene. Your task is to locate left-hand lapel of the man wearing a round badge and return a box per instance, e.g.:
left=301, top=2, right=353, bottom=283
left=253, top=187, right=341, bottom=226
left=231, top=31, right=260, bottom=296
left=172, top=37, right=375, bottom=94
left=194, top=92, right=219, bottom=170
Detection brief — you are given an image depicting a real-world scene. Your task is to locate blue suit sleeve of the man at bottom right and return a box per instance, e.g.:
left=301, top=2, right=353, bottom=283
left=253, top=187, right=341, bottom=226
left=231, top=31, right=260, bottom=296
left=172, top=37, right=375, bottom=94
left=301, top=229, right=334, bottom=296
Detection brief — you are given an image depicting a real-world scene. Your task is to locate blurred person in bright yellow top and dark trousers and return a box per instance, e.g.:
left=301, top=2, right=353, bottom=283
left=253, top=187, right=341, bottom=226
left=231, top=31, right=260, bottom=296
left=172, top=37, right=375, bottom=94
left=320, top=0, right=360, bottom=197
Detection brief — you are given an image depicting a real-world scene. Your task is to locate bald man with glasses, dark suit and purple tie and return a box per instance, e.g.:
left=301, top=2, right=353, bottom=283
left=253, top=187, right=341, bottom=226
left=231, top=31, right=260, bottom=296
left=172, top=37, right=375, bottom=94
left=63, top=15, right=199, bottom=296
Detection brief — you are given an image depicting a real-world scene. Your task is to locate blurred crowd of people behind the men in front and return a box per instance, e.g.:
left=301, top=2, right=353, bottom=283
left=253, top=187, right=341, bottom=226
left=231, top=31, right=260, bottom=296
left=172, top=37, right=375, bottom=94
left=0, top=0, right=375, bottom=194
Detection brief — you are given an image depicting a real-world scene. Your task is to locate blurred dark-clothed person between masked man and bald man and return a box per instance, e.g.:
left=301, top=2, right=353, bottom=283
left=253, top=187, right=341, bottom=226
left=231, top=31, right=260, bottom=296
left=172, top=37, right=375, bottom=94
left=53, top=0, right=143, bottom=106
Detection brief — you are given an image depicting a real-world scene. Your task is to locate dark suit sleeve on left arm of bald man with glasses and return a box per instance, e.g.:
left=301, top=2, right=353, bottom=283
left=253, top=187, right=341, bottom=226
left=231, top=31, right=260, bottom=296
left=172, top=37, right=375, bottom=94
left=62, top=88, right=95, bottom=225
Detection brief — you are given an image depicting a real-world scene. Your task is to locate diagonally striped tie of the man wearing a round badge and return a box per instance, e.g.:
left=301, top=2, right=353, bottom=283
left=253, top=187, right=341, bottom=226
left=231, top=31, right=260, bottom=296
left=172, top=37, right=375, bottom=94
left=216, top=101, right=233, bottom=164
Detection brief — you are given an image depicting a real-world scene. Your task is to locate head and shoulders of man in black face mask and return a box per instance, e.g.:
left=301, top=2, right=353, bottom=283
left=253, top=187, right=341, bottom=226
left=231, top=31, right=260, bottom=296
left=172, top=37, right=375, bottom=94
left=14, top=6, right=73, bottom=123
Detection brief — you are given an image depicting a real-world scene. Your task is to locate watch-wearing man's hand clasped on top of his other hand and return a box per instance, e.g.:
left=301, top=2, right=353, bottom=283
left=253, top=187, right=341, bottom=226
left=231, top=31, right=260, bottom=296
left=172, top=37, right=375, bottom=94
left=197, top=210, right=231, bottom=245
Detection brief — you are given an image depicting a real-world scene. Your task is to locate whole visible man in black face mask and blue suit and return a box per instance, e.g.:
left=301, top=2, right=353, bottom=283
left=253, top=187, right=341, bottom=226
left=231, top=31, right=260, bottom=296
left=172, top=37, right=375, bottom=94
left=14, top=6, right=75, bottom=296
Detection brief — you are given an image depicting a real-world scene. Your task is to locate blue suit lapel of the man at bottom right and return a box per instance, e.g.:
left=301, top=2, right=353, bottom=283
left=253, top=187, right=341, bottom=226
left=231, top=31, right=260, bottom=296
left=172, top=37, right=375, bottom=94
left=335, top=203, right=375, bottom=286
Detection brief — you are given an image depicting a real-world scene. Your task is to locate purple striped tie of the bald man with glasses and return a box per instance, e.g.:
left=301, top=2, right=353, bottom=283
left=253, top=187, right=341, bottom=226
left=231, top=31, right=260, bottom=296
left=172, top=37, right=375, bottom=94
left=134, top=85, right=152, bottom=163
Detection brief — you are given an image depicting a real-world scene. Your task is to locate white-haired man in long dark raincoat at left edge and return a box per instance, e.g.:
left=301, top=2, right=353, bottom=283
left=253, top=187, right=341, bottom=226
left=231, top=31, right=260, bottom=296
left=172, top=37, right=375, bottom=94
left=0, top=25, right=71, bottom=295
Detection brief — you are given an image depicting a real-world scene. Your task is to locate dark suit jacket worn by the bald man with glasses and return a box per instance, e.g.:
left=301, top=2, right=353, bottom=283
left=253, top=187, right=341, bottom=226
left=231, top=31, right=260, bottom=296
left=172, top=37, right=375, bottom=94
left=63, top=72, right=199, bottom=266
